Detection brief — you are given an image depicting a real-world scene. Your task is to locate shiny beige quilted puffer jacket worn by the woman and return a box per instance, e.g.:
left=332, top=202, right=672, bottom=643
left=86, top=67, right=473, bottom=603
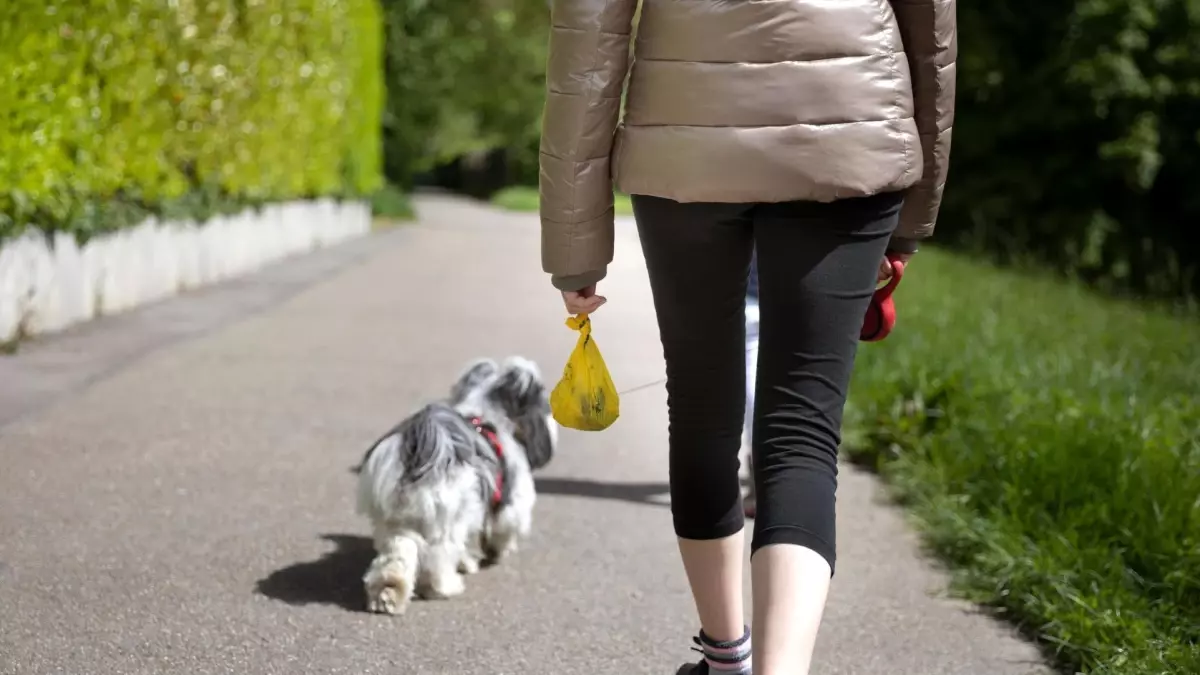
left=541, top=0, right=958, bottom=289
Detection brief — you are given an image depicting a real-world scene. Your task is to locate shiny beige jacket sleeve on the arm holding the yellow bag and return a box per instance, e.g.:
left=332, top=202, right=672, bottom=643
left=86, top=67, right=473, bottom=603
left=540, top=0, right=637, bottom=291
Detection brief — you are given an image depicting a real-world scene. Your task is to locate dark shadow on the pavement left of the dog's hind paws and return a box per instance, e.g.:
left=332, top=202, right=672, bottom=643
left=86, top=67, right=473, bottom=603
left=256, top=534, right=374, bottom=611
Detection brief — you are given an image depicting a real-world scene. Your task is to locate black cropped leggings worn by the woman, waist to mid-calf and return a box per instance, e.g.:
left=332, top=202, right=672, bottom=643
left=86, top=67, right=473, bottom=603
left=634, top=193, right=902, bottom=567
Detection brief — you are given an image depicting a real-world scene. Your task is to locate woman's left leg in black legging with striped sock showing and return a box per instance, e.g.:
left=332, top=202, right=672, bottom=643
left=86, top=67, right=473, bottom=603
left=632, top=196, right=752, bottom=674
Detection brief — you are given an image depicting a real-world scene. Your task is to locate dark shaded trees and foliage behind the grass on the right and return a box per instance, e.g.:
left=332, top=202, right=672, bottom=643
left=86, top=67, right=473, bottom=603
left=937, top=0, right=1200, bottom=295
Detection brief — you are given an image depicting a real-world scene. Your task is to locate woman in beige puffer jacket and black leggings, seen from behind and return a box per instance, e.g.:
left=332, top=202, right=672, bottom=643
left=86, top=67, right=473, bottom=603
left=541, top=0, right=958, bottom=675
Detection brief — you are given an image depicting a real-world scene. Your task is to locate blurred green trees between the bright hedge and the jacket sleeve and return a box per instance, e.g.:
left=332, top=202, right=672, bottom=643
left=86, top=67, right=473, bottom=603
left=383, top=0, right=550, bottom=186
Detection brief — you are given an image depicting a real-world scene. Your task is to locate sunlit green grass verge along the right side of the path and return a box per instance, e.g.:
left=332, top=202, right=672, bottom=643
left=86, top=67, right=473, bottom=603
left=846, top=251, right=1200, bottom=675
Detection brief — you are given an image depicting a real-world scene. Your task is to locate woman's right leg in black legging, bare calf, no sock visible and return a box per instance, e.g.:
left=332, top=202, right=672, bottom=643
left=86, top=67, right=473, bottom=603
left=751, top=195, right=901, bottom=675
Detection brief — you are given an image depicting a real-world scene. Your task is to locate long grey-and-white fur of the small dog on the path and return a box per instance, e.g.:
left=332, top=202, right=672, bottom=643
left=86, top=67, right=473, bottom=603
left=358, top=357, right=558, bottom=614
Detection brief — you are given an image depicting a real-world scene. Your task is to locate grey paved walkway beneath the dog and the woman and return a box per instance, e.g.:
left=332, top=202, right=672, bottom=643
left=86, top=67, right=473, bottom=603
left=0, top=196, right=1039, bottom=675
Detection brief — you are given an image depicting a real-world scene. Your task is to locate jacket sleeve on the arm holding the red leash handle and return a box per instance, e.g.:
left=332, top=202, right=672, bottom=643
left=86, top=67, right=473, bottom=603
left=892, top=0, right=959, bottom=250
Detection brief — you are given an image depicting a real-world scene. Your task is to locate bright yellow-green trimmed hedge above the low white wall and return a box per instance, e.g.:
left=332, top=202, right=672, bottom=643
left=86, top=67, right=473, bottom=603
left=0, top=0, right=383, bottom=237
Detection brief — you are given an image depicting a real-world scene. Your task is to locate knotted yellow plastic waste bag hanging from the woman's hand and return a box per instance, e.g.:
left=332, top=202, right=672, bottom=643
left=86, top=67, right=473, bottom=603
left=550, top=313, right=620, bottom=431
